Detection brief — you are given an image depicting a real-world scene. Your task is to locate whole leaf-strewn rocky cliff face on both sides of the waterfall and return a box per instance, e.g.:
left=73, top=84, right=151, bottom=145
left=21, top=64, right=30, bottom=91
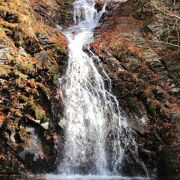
left=0, top=0, right=180, bottom=179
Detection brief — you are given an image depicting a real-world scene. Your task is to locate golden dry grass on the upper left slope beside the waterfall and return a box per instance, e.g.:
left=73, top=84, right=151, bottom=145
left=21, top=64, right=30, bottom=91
left=0, top=0, right=67, bottom=51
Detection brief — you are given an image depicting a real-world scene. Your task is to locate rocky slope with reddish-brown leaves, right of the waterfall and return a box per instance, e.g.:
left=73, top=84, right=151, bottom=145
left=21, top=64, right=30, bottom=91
left=91, top=0, right=180, bottom=179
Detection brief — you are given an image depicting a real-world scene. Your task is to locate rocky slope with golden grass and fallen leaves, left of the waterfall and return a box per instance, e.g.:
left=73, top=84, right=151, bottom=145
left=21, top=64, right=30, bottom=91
left=0, top=0, right=71, bottom=174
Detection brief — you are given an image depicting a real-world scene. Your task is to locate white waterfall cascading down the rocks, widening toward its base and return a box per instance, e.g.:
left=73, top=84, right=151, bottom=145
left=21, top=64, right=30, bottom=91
left=47, top=0, right=148, bottom=179
